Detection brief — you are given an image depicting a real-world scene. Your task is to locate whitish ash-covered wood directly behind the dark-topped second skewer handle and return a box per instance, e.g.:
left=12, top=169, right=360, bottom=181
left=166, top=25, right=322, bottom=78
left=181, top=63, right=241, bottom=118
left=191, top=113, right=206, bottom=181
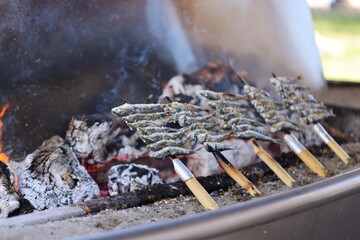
left=186, top=139, right=257, bottom=176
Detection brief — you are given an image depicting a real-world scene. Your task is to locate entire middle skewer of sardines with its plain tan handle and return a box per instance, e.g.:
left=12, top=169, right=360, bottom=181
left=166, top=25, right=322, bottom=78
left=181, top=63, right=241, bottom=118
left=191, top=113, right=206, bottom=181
left=200, top=90, right=295, bottom=187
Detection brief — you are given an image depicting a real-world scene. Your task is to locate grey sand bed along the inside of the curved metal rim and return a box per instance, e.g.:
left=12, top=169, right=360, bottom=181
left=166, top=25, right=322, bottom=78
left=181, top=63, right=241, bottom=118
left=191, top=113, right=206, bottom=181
left=0, top=143, right=360, bottom=239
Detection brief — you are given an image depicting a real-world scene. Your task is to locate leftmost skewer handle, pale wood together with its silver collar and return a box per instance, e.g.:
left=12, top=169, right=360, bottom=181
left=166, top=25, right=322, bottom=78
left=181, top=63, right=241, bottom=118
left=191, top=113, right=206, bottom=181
left=172, top=158, right=219, bottom=210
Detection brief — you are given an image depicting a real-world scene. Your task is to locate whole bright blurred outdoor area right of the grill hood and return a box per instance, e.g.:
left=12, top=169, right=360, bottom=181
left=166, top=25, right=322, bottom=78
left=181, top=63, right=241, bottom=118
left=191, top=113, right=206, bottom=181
left=308, top=0, right=360, bottom=82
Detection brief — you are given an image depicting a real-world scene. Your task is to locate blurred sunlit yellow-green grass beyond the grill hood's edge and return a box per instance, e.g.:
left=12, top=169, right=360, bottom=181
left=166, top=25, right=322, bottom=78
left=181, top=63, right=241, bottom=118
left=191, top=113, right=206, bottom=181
left=312, top=11, right=360, bottom=82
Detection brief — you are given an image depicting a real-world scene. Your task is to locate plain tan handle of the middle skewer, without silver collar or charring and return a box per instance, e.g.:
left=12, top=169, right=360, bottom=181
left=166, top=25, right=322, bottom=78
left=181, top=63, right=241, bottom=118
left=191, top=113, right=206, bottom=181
left=250, top=138, right=295, bottom=187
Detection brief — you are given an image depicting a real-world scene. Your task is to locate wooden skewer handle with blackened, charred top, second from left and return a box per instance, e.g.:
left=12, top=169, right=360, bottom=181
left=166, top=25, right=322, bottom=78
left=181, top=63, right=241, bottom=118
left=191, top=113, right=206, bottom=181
left=212, top=151, right=261, bottom=196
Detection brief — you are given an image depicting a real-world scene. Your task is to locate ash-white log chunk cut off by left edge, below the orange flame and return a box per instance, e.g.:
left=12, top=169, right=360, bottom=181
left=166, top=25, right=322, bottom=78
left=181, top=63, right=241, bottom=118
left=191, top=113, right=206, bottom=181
left=0, top=161, right=20, bottom=218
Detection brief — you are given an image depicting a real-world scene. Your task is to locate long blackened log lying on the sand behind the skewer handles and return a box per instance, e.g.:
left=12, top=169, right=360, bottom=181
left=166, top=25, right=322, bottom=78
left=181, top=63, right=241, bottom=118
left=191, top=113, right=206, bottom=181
left=78, top=148, right=304, bottom=214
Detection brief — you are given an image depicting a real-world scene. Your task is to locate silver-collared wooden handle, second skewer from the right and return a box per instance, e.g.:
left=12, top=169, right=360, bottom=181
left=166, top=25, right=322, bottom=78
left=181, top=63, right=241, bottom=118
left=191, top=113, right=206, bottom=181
left=284, top=133, right=328, bottom=177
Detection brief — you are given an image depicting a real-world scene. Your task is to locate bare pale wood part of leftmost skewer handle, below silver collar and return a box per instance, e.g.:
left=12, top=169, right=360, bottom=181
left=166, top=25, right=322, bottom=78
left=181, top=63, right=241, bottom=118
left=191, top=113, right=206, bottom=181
left=185, top=178, right=219, bottom=210
